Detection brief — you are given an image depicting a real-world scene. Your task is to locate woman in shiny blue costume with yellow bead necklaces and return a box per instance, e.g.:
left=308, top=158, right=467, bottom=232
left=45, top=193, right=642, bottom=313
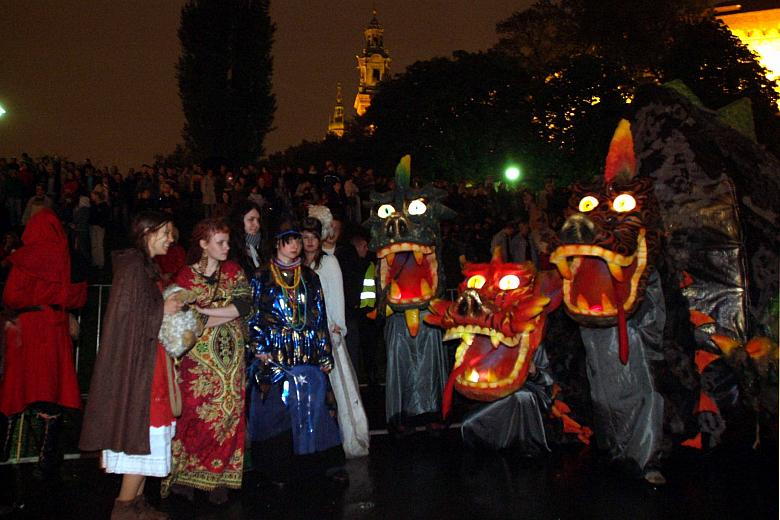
left=248, top=225, right=345, bottom=488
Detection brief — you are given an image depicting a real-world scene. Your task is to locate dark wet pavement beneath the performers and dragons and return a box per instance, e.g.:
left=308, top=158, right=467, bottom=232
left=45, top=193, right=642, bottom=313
left=0, top=386, right=778, bottom=520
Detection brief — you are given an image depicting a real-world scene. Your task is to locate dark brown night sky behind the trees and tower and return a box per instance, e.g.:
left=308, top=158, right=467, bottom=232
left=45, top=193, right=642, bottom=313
left=0, top=0, right=531, bottom=168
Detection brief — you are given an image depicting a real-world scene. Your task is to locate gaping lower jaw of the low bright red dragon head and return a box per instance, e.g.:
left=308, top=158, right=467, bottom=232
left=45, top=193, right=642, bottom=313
left=445, top=331, right=538, bottom=401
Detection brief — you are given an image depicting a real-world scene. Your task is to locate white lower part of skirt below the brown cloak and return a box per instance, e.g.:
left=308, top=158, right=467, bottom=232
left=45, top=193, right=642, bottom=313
left=100, top=421, right=176, bottom=477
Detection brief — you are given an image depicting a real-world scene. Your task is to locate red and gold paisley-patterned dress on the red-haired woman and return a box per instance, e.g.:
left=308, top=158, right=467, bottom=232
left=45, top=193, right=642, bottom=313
left=162, top=261, right=251, bottom=497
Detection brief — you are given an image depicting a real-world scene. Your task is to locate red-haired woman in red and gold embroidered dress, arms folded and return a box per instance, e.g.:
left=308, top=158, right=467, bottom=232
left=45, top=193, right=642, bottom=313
left=162, top=219, right=252, bottom=504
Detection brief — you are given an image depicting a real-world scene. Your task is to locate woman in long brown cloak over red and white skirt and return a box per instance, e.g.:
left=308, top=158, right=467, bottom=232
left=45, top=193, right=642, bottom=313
left=79, top=211, right=182, bottom=520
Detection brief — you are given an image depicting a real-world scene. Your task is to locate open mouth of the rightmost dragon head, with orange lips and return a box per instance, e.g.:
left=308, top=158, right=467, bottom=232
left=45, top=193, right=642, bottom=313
left=550, top=229, right=647, bottom=318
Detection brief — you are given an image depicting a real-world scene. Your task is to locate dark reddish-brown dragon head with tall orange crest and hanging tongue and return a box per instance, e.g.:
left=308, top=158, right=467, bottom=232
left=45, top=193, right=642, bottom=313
left=550, top=120, right=661, bottom=363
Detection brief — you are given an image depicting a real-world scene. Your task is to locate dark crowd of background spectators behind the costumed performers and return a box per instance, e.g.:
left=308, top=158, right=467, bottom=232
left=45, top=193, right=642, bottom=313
left=0, top=153, right=568, bottom=287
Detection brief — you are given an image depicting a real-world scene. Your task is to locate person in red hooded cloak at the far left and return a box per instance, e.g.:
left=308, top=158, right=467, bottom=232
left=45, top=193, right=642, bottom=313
left=0, top=208, right=87, bottom=477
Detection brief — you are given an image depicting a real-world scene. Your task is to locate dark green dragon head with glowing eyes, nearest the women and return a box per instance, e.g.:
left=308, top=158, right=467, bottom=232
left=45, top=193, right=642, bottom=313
left=366, top=155, right=455, bottom=336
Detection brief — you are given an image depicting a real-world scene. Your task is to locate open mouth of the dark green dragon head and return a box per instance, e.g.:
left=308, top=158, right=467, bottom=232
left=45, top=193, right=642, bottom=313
left=376, top=242, right=439, bottom=305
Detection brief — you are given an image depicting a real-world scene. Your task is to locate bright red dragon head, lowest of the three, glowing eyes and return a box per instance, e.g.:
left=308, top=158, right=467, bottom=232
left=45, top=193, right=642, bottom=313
left=425, top=252, right=561, bottom=415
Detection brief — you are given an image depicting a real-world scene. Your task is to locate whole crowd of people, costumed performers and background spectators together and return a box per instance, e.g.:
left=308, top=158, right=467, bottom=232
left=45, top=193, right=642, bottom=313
left=0, top=155, right=565, bottom=519
